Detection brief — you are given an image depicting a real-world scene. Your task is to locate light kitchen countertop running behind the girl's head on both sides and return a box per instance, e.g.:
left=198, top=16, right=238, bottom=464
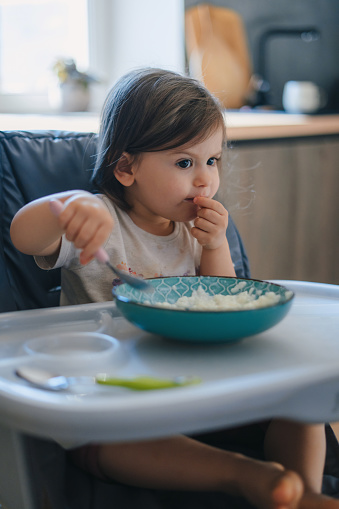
left=0, top=111, right=339, bottom=141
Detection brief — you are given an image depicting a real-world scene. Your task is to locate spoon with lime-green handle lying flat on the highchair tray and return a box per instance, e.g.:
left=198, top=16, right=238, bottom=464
left=15, top=366, right=201, bottom=391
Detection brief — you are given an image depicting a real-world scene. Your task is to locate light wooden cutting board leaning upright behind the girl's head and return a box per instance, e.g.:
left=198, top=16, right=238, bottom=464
left=185, top=4, right=252, bottom=109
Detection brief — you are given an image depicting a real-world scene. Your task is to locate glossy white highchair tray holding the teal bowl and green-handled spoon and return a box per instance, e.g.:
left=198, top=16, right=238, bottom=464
left=0, top=281, right=339, bottom=443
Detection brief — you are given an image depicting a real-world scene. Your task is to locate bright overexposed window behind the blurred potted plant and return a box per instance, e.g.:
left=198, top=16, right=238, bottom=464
left=0, top=0, right=89, bottom=111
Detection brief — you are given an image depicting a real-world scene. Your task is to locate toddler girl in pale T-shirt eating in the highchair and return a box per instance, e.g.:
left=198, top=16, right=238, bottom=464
left=11, top=69, right=339, bottom=509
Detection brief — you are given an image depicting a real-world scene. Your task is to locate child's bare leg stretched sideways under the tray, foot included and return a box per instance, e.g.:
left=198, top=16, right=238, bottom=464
left=98, top=436, right=303, bottom=509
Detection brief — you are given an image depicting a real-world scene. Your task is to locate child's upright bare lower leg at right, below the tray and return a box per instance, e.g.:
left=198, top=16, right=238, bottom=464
left=265, top=420, right=339, bottom=509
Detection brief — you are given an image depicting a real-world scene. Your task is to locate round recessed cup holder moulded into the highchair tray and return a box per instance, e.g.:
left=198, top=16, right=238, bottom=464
left=24, top=332, right=119, bottom=370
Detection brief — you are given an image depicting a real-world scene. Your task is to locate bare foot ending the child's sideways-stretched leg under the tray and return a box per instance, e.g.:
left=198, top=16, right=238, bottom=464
left=232, top=458, right=304, bottom=509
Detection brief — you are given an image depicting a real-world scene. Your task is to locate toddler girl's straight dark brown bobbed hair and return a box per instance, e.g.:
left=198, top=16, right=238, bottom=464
left=92, top=68, right=224, bottom=210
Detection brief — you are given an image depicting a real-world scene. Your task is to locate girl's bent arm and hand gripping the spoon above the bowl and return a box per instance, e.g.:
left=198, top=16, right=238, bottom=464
left=10, top=191, right=113, bottom=263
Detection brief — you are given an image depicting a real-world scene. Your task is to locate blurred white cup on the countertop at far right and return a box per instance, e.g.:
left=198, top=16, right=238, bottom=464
left=282, top=81, right=326, bottom=113
